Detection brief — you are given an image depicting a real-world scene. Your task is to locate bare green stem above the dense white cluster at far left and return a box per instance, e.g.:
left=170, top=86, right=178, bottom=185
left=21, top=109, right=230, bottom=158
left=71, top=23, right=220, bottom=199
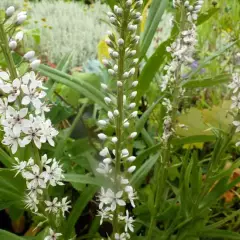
left=0, top=23, right=18, bottom=80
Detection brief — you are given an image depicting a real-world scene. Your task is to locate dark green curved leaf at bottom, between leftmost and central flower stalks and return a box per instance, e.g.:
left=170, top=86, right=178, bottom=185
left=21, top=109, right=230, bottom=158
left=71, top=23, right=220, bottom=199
left=64, top=186, right=98, bottom=239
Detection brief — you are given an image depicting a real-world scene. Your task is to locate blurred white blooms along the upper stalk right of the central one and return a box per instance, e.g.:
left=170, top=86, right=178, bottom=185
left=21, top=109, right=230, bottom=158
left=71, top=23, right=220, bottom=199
left=160, top=0, right=203, bottom=142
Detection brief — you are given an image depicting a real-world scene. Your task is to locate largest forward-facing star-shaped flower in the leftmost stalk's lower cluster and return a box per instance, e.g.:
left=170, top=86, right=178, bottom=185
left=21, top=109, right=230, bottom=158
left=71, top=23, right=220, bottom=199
left=22, top=164, right=46, bottom=188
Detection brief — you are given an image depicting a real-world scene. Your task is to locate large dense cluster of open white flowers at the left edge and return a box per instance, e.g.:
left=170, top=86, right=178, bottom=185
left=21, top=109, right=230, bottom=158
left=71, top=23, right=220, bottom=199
left=0, top=72, right=58, bottom=153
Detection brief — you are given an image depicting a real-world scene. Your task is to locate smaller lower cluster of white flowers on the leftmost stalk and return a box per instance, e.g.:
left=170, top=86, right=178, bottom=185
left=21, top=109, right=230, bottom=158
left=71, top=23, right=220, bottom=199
left=13, top=154, right=70, bottom=216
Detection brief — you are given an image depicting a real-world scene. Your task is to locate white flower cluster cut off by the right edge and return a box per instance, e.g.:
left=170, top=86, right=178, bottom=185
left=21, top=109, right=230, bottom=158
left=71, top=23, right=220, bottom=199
left=228, top=73, right=240, bottom=147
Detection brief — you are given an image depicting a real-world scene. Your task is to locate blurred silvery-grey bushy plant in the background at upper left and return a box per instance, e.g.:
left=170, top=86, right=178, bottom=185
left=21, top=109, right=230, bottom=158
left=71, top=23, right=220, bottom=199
left=0, top=0, right=109, bottom=67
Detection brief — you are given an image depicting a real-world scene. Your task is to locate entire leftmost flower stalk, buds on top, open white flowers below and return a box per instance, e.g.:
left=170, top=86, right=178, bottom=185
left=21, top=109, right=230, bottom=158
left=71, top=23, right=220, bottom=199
left=0, top=6, right=70, bottom=240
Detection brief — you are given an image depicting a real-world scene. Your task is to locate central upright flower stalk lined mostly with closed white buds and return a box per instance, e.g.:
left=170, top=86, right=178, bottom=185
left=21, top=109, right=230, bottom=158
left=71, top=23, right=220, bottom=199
left=97, top=0, right=142, bottom=239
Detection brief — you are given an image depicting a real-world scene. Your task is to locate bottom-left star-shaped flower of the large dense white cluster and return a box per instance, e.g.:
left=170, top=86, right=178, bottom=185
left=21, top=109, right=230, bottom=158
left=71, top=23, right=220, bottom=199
left=2, top=128, right=24, bottom=154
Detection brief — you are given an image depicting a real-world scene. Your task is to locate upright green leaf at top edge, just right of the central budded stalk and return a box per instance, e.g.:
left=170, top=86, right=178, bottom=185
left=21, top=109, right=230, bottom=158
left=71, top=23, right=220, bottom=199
left=140, top=0, right=168, bottom=59
